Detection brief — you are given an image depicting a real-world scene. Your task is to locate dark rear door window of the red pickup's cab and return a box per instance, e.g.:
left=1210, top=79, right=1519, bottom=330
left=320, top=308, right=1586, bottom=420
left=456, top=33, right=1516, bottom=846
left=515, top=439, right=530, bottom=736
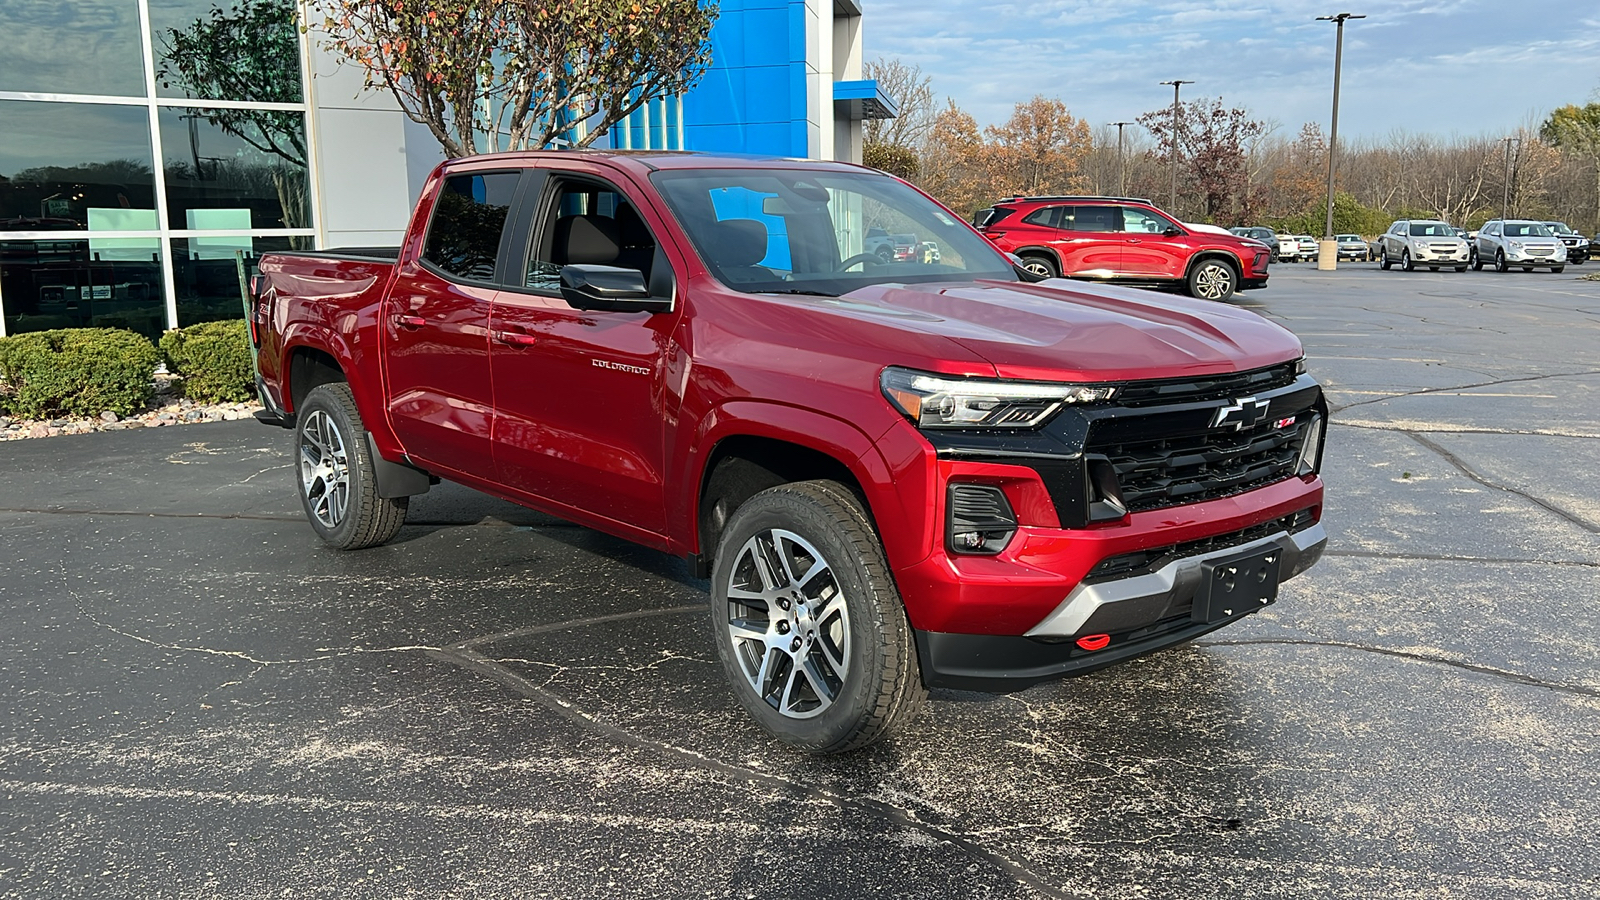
left=422, top=171, right=520, bottom=282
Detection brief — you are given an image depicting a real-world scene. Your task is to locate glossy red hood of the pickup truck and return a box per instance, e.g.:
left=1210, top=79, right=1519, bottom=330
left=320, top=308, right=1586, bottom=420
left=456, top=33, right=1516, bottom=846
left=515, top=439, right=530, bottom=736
left=829, top=279, right=1301, bottom=381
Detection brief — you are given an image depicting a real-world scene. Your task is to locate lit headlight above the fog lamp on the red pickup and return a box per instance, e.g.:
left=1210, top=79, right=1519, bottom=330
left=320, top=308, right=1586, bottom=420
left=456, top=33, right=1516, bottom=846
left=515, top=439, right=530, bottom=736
left=878, top=367, right=1117, bottom=428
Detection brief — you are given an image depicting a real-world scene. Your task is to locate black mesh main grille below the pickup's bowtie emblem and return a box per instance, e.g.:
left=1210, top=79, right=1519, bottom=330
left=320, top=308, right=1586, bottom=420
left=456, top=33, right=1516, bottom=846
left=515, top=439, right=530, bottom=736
left=1085, top=416, right=1302, bottom=512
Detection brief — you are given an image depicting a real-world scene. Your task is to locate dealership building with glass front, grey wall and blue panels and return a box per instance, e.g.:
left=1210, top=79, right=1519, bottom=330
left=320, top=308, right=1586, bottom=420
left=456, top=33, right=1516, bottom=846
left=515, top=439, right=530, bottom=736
left=0, top=0, right=894, bottom=338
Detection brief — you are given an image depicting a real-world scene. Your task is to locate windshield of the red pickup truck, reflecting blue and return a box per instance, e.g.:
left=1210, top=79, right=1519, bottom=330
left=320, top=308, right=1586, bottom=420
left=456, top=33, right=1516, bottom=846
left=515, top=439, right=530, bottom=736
left=651, top=168, right=1016, bottom=296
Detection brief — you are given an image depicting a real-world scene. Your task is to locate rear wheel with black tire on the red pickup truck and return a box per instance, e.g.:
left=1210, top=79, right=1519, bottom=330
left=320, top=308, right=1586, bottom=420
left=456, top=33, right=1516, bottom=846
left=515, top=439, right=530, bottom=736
left=294, top=381, right=411, bottom=549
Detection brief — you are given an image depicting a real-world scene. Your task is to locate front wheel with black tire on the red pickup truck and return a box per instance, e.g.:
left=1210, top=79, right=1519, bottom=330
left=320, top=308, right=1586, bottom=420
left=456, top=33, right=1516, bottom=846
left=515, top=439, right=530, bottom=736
left=710, top=480, right=928, bottom=753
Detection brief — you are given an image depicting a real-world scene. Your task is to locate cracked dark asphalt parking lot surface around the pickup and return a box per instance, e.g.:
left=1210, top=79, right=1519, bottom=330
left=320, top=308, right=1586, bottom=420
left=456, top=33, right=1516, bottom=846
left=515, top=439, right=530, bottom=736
left=0, top=264, right=1600, bottom=900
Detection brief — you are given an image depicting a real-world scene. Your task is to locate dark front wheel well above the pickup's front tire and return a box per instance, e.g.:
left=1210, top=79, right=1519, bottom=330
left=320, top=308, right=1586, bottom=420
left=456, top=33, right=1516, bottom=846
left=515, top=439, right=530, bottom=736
left=693, top=436, right=872, bottom=578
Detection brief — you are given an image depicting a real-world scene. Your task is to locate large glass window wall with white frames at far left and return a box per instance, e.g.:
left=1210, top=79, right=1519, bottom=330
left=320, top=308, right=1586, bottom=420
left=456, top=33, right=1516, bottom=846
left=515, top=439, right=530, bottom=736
left=0, top=0, right=317, bottom=338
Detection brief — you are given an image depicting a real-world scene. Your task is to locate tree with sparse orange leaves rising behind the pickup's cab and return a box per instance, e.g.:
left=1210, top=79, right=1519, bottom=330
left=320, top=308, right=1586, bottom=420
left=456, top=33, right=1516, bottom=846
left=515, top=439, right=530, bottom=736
left=320, top=0, right=717, bottom=157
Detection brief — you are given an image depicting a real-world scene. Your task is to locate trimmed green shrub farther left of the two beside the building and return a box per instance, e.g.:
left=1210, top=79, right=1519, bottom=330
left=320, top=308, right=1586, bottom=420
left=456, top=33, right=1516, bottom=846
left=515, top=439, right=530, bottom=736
left=0, top=328, right=160, bottom=418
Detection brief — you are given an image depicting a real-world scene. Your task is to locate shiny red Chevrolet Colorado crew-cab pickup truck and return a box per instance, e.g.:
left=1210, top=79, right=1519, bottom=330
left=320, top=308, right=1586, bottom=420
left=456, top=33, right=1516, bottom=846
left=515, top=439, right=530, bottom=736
left=250, top=152, right=1328, bottom=751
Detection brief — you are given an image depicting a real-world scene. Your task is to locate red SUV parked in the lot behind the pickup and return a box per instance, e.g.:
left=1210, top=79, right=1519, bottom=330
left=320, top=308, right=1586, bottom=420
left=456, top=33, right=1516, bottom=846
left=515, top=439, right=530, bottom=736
left=973, top=197, right=1270, bottom=299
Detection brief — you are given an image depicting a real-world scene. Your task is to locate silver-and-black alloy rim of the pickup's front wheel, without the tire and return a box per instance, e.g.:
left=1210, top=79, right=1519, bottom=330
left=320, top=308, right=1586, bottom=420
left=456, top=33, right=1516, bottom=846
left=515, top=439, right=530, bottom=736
left=728, top=528, right=851, bottom=719
